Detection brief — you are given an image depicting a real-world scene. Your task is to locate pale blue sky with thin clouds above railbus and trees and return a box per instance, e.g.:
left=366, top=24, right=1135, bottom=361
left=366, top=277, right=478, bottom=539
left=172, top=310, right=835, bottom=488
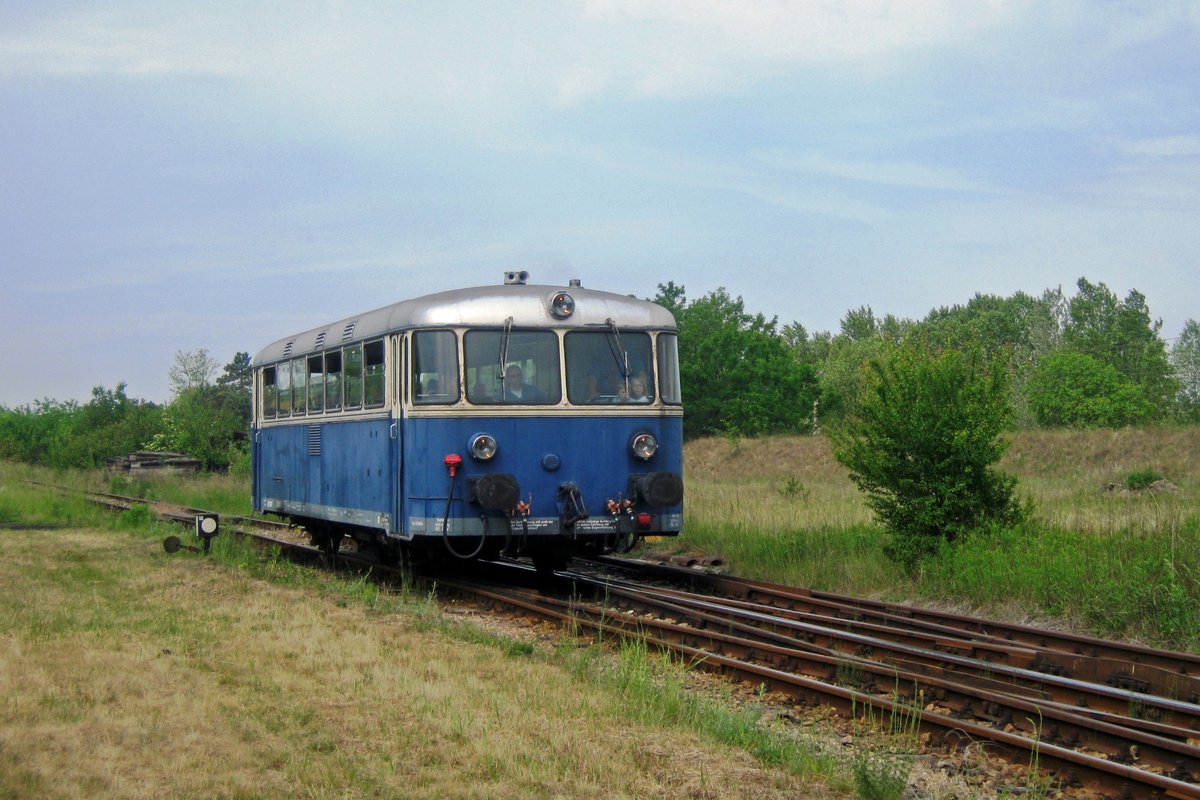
left=0, top=0, right=1200, bottom=408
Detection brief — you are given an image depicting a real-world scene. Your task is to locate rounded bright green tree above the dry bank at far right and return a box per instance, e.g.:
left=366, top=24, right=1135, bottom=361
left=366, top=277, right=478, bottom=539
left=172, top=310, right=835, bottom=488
left=1026, top=350, right=1152, bottom=428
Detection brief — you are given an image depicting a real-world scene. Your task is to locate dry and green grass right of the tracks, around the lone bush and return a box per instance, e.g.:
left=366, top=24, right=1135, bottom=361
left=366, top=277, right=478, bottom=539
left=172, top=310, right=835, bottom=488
left=676, top=427, right=1200, bottom=651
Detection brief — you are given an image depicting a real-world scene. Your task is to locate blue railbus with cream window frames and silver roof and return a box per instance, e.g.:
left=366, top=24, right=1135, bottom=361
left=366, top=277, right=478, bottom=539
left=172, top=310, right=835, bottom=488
left=252, top=272, right=683, bottom=571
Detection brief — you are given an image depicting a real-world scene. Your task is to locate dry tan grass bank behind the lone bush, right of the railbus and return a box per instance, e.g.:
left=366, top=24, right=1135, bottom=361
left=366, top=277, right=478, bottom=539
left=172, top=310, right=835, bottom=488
left=685, top=426, right=1200, bottom=534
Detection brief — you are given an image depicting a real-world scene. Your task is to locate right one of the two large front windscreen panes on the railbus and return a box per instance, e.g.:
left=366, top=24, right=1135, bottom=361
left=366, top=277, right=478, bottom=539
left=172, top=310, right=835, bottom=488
left=564, top=329, right=655, bottom=405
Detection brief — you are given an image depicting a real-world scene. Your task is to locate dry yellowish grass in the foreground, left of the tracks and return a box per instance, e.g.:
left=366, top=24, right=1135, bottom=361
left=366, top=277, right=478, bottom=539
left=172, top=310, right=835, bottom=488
left=0, top=530, right=829, bottom=799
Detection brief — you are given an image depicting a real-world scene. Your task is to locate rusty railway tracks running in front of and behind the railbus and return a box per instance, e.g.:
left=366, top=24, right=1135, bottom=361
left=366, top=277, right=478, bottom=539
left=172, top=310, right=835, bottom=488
left=72, top=494, right=1200, bottom=799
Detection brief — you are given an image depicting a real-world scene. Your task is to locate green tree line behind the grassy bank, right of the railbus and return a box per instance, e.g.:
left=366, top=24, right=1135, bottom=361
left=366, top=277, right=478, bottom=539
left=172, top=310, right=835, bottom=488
left=654, top=278, right=1200, bottom=438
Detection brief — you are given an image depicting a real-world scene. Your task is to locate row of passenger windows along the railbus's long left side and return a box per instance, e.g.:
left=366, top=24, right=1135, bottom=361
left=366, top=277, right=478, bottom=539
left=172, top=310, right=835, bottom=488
left=259, top=339, right=386, bottom=420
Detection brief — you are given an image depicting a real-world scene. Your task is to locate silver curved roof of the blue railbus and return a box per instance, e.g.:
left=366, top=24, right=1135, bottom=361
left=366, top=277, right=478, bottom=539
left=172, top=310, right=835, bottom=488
left=254, top=284, right=676, bottom=365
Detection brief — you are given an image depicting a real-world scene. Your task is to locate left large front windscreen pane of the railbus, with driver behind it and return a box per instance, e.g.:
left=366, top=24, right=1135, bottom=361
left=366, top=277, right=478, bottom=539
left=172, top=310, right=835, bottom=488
left=463, top=331, right=563, bottom=405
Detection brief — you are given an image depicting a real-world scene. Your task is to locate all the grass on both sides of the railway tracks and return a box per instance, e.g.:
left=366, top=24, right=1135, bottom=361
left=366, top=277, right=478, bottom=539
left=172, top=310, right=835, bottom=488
left=0, top=428, right=1200, bottom=798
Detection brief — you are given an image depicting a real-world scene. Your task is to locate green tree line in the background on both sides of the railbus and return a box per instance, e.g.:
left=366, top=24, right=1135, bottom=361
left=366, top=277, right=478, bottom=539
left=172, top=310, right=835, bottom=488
left=0, top=278, right=1200, bottom=470
